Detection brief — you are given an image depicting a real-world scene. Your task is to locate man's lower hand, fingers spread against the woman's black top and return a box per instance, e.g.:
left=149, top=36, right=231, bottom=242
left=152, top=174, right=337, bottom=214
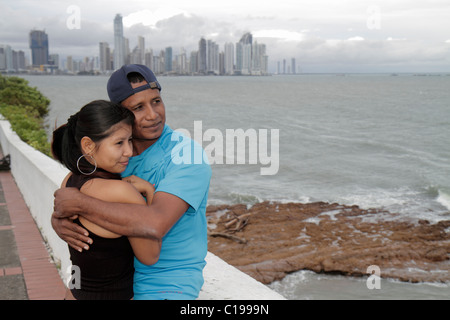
left=51, top=214, right=92, bottom=252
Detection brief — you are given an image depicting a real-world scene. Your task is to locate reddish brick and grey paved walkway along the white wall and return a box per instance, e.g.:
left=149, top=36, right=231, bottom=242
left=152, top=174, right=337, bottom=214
left=0, top=161, right=65, bottom=300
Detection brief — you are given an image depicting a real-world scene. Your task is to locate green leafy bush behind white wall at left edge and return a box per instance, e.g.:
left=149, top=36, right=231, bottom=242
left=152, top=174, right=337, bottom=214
left=0, top=75, right=51, bottom=156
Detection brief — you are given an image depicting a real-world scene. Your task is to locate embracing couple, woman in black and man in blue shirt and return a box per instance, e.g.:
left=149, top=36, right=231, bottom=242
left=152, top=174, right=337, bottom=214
left=52, top=65, right=211, bottom=300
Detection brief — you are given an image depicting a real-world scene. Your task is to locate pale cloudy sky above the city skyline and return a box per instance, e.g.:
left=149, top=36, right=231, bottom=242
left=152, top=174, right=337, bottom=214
left=0, top=0, right=450, bottom=72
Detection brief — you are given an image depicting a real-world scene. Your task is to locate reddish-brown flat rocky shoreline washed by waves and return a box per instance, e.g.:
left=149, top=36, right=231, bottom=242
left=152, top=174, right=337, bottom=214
left=207, top=202, right=450, bottom=284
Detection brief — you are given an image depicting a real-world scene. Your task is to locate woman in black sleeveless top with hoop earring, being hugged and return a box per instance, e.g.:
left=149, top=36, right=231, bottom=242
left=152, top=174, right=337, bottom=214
left=52, top=100, right=160, bottom=300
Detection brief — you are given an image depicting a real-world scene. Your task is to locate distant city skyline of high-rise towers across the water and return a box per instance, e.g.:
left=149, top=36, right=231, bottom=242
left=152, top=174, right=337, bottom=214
left=0, top=22, right=274, bottom=76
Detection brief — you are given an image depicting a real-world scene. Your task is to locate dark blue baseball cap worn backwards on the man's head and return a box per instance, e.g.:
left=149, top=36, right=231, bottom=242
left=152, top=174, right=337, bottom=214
left=107, top=64, right=161, bottom=103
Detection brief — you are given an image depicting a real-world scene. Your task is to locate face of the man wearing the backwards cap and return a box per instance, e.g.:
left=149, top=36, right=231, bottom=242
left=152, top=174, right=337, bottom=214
left=122, top=81, right=166, bottom=141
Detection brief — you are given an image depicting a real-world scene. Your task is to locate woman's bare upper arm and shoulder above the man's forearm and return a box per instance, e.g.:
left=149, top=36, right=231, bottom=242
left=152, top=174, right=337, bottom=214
left=81, top=178, right=145, bottom=204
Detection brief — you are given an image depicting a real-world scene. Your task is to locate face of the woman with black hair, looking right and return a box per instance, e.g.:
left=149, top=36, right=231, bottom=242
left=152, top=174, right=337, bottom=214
left=92, top=122, right=133, bottom=173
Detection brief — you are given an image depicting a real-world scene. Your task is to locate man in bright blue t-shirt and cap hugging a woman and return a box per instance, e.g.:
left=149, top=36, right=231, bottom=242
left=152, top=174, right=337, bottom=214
left=52, top=65, right=211, bottom=299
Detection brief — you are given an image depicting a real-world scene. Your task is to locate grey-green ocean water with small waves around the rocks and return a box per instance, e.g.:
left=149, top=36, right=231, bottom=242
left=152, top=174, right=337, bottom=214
left=19, top=74, right=450, bottom=299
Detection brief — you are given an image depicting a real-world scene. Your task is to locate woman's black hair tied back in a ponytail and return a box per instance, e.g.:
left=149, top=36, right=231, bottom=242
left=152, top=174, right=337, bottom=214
left=52, top=100, right=134, bottom=174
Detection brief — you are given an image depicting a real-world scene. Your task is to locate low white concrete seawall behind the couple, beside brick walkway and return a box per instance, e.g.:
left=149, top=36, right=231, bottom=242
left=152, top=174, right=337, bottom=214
left=0, top=120, right=284, bottom=300
